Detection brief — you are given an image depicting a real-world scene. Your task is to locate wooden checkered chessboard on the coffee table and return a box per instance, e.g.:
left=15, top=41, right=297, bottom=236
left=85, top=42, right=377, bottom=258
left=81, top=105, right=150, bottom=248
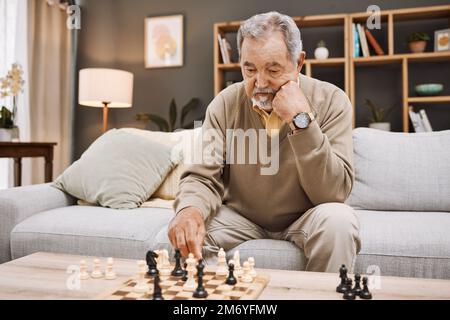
left=97, top=267, right=269, bottom=300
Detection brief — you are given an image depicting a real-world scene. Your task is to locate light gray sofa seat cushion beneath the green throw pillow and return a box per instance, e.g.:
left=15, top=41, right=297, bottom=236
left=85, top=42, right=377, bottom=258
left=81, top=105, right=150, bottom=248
left=11, top=206, right=173, bottom=259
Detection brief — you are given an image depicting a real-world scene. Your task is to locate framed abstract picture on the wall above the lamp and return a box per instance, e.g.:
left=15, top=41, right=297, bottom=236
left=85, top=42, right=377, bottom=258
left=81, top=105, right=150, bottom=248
left=145, top=15, right=183, bottom=68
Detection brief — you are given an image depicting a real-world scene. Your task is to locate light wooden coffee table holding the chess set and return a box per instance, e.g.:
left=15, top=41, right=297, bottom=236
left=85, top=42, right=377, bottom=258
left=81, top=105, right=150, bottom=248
left=0, top=253, right=450, bottom=301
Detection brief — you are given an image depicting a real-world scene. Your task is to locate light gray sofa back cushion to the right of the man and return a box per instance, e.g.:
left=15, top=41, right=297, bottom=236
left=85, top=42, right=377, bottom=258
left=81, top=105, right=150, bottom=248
left=346, top=128, right=450, bottom=211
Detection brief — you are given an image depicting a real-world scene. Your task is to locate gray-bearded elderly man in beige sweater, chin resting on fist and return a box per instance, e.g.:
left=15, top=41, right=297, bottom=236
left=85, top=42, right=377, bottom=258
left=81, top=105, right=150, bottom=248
left=168, top=12, right=360, bottom=272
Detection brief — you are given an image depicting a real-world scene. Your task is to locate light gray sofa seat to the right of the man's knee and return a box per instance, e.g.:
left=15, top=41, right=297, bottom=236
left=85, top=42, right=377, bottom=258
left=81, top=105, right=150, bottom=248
left=355, top=210, right=450, bottom=278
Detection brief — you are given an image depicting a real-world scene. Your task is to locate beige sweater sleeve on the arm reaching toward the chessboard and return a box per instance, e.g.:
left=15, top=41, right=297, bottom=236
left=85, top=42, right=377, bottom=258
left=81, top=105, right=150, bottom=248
left=174, top=94, right=226, bottom=220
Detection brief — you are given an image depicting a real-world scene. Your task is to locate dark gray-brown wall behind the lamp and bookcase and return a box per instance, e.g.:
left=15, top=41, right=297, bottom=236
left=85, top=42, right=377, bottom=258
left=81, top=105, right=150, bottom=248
left=74, top=0, right=450, bottom=159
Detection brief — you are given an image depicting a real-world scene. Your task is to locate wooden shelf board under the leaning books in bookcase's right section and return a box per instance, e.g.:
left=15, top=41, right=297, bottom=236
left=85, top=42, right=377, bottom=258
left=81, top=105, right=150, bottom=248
left=352, top=51, right=450, bottom=66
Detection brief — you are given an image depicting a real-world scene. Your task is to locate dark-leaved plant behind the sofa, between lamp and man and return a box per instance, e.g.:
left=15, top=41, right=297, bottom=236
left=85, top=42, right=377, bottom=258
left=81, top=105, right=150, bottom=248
left=135, top=98, right=203, bottom=132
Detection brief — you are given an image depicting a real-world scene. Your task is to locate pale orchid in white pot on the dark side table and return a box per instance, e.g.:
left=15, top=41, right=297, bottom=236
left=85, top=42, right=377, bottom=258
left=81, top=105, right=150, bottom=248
left=0, top=63, right=25, bottom=141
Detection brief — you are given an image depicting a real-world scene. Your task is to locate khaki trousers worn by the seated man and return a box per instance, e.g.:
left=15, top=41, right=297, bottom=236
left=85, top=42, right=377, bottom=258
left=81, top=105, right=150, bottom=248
left=203, top=203, right=361, bottom=273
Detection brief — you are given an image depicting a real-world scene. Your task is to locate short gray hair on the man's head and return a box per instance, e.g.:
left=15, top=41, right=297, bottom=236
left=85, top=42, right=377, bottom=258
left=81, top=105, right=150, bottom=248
left=237, top=11, right=302, bottom=63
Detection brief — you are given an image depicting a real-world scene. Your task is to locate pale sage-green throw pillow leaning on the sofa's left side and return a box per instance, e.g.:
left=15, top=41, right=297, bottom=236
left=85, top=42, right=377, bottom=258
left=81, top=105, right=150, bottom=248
left=53, top=129, right=181, bottom=209
